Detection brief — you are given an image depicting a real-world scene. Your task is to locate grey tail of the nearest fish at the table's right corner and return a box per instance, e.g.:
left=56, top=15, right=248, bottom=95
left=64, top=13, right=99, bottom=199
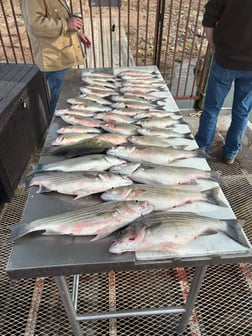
left=222, top=219, right=247, bottom=247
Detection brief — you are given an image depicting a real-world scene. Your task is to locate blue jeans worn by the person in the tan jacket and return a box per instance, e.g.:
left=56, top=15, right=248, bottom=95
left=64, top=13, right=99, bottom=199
left=44, top=69, right=67, bottom=115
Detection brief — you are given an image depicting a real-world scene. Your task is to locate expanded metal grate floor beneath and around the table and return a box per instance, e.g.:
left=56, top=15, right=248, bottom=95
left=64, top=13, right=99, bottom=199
left=0, top=148, right=252, bottom=336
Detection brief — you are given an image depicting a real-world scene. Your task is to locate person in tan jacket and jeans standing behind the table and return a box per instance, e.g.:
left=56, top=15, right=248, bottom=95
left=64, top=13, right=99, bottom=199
left=21, top=0, right=91, bottom=114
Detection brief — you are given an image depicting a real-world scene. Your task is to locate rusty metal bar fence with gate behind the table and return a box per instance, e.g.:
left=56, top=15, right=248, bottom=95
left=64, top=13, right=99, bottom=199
left=0, top=0, right=208, bottom=100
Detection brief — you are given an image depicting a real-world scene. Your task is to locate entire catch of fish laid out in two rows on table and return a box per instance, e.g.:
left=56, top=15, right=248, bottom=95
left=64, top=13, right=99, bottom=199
left=3, top=71, right=246, bottom=253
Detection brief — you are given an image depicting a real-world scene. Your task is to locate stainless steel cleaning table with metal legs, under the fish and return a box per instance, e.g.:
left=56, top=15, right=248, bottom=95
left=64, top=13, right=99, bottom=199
left=6, top=67, right=252, bottom=336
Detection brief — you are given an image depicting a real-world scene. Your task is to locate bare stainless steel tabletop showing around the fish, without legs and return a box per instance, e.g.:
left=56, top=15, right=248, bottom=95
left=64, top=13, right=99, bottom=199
left=6, top=66, right=252, bottom=279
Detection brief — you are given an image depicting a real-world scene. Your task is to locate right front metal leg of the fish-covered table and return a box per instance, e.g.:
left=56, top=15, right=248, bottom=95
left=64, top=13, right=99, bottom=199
left=178, top=266, right=207, bottom=334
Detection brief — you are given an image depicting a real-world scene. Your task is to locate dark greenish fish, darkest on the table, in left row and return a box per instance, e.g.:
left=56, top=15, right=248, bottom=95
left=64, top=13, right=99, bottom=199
left=49, top=136, right=113, bottom=158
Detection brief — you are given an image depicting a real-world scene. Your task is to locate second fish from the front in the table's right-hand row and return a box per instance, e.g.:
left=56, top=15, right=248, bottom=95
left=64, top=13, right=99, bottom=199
left=101, top=183, right=228, bottom=211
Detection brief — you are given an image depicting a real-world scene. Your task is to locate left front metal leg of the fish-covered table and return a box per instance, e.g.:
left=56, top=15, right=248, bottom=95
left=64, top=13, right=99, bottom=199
left=54, top=275, right=83, bottom=336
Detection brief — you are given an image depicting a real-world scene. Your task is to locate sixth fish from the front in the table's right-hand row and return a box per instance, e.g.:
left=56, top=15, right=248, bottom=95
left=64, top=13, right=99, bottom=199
left=138, top=127, right=193, bottom=139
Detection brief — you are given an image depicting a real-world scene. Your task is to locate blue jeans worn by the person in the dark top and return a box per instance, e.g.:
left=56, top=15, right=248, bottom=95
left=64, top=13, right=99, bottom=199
left=195, top=58, right=252, bottom=159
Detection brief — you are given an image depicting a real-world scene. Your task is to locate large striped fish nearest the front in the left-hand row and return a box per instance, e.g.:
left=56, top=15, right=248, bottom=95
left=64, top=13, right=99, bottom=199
left=4, top=201, right=153, bottom=244
